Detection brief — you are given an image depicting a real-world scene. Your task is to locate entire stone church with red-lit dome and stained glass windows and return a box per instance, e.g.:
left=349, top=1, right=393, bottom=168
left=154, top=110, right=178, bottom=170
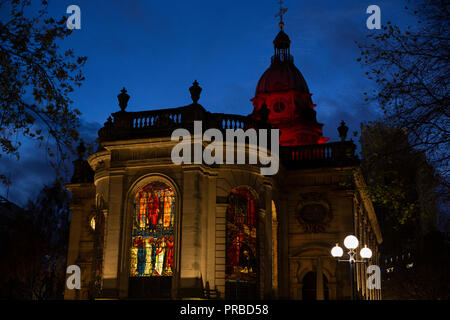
left=65, top=23, right=382, bottom=300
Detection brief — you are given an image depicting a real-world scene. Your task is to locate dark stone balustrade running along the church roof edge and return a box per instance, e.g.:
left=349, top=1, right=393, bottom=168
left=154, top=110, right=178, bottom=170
left=99, top=104, right=359, bottom=168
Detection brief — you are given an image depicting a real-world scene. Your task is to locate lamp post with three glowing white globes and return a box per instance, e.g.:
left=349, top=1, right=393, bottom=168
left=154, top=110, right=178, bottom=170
left=331, top=235, right=372, bottom=300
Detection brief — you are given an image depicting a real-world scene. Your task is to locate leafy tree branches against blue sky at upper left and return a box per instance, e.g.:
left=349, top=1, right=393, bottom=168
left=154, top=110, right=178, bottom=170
left=0, top=0, right=86, bottom=182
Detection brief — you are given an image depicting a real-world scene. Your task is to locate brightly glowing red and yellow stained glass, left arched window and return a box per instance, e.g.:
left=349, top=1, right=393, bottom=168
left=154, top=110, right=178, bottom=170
left=130, top=182, right=175, bottom=277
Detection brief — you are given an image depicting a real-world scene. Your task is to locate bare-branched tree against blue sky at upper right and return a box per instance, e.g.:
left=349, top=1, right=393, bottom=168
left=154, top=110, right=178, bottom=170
left=358, top=0, right=450, bottom=193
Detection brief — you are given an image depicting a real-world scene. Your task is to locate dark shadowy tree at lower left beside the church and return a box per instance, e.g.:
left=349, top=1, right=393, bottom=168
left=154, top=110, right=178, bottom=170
left=0, top=180, right=70, bottom=300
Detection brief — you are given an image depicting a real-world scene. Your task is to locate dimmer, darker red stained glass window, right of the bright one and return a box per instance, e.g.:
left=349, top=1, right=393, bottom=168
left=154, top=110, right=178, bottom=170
left=226, top=188, right=257, bottom=285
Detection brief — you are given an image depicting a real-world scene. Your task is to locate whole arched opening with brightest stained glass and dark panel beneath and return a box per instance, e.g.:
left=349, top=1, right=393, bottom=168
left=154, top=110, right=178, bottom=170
left=129, top=181, right=176, bottom=298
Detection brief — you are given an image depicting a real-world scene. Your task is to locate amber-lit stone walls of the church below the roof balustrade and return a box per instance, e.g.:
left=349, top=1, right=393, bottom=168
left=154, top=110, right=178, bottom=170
left=66, top=131, right=381, bottom=299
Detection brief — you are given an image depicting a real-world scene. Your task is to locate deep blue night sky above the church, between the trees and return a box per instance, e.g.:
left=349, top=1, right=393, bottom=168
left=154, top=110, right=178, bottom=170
left=0, top=0, right=410, bottom=205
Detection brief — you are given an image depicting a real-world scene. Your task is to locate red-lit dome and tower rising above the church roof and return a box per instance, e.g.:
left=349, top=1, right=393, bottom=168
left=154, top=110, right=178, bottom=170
left=252, top=28, right=329, bottom=146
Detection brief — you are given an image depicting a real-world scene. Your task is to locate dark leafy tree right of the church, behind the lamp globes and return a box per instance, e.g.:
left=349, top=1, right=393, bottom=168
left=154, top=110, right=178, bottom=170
left=361, top=123, right=439, bottom=247
